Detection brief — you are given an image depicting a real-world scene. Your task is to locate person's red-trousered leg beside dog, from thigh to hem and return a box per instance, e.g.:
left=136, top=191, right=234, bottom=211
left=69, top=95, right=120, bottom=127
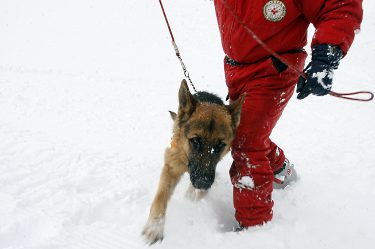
left=230, top=79, right=294, bottom=227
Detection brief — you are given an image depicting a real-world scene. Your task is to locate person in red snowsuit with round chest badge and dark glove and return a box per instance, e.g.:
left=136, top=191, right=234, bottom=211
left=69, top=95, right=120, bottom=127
left=214, top=0, right=362, bottom=227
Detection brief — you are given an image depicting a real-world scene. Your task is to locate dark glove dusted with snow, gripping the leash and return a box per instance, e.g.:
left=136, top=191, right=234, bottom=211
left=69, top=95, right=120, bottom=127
left=297, top=44, right=343, bottom=99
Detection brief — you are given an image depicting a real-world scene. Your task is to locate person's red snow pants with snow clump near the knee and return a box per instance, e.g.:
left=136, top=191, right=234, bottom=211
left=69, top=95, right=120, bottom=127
left=225, top=53, right=306, bottom=227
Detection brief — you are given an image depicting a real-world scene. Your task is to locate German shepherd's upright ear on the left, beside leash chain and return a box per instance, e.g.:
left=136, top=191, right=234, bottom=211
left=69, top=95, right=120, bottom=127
left=178, top=80, right=197, bottom=122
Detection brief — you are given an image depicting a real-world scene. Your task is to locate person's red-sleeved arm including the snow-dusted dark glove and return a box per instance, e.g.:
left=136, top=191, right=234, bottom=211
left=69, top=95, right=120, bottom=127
left=296, top=0, right=363, bottom=99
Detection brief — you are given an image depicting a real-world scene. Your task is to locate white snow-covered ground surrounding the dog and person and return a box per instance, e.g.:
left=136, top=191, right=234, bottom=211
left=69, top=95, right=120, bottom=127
left=0, top=0, right=375, bottom=249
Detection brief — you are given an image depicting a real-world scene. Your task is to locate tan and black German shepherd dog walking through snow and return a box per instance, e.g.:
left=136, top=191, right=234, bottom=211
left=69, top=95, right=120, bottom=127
left=142, top=80, right=245, bottom=244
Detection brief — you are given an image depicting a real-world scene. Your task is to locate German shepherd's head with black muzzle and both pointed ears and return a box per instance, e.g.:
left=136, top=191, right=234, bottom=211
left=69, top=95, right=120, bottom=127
left=171, top=80, right=245, bottom=189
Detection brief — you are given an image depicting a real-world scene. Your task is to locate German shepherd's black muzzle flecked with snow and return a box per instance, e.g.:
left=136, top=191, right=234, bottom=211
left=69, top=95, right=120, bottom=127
left=189, top=162, right=216, bottom=190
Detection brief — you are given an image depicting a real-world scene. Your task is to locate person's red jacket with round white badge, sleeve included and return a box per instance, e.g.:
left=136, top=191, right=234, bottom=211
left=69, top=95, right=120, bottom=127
left=215, top=0, right=363, bottom=63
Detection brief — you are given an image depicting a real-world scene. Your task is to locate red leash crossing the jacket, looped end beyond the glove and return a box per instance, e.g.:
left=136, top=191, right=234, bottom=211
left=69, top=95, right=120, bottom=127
left=221, top=0, right=374, bottom=102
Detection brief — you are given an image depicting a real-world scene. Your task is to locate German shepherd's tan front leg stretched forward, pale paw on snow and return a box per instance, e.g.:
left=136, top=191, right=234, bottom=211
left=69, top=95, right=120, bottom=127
left=142, top=153, right=186, bottom=244
